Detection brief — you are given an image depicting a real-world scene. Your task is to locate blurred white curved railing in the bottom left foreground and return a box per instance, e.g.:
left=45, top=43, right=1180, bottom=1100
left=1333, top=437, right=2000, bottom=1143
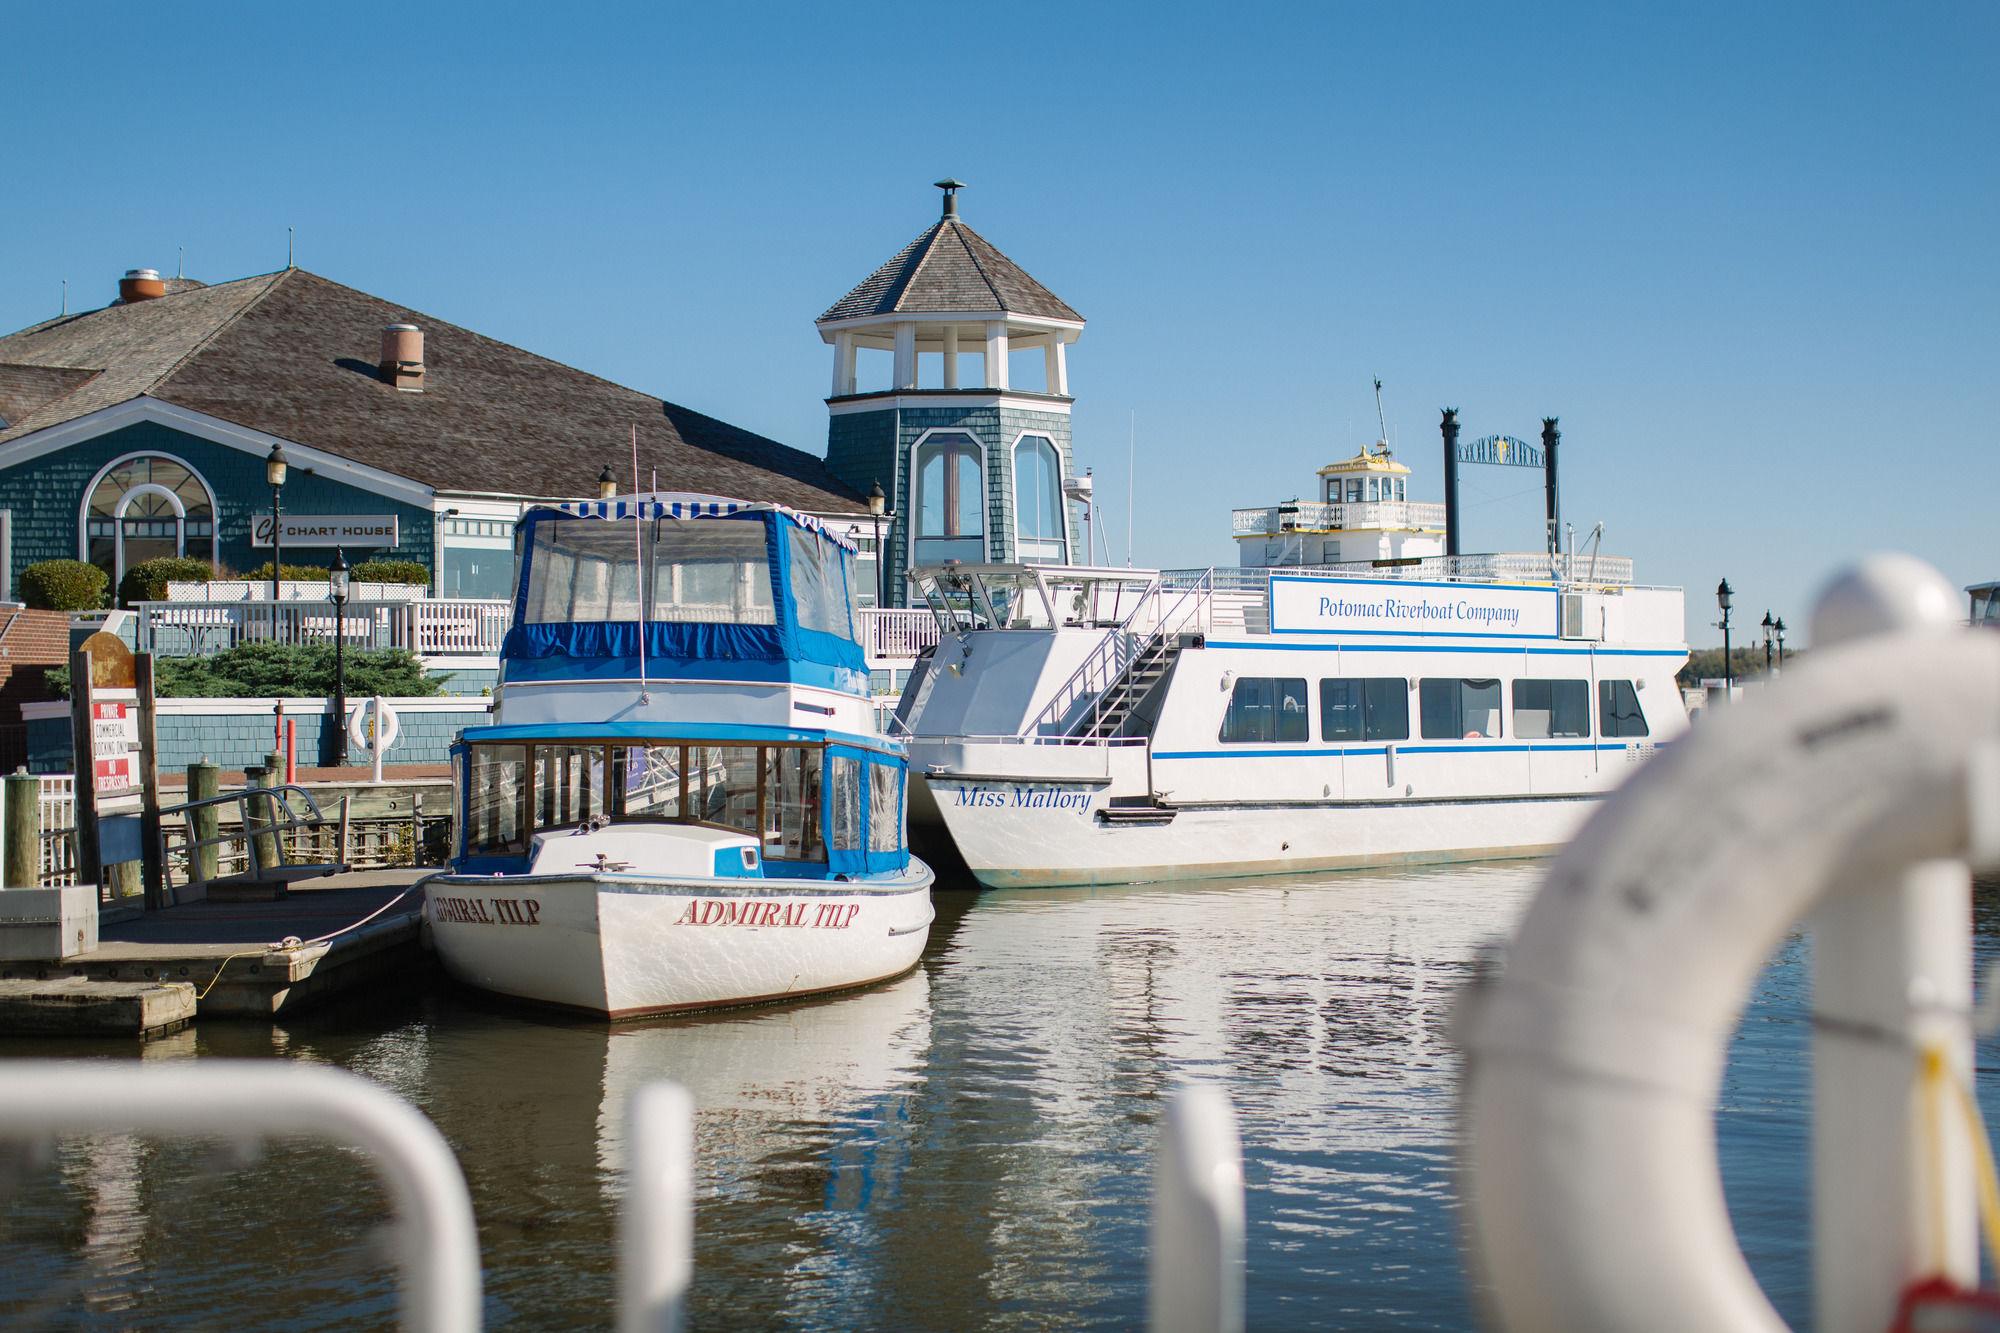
left=0, top=1061, right=480, bottom=1333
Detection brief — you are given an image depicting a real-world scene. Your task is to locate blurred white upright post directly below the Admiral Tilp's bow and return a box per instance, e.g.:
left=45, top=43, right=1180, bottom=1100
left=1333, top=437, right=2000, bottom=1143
left=618, top=1081, right=694, bottom=1333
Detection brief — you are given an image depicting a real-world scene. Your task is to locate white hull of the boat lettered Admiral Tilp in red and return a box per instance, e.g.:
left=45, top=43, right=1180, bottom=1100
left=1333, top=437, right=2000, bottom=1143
left=424, top=861, right=932, bottom=1019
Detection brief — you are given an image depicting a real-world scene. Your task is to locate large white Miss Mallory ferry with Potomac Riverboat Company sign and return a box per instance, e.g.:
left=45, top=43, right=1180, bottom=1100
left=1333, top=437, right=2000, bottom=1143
left=898, top=436, right=1688, bottom=887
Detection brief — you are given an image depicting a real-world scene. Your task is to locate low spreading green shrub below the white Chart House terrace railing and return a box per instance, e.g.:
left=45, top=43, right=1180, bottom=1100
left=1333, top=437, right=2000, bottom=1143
left=48, top=642, right=448, bottom=699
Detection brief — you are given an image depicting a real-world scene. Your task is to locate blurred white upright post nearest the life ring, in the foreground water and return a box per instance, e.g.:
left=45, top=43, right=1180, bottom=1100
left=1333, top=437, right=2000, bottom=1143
left=1146, top=1083, right=1244, bottom=1333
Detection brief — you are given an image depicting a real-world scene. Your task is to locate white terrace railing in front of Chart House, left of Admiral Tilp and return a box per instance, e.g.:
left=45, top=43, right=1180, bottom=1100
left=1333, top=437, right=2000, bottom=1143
left=136, top=598, right=512, bottom=656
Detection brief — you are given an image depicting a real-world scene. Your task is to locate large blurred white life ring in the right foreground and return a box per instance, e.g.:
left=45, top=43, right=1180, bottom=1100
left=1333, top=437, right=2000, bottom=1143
left=1462, top=560, right=2000, bottom=1333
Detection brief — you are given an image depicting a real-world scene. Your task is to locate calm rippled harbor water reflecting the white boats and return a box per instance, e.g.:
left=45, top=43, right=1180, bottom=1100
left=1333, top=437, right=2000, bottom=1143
left=0, top=865, right=2000, bottom=1329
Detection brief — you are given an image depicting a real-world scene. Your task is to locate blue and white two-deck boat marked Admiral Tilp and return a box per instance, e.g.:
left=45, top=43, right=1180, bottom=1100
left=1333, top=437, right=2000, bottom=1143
left=424, top=494, right=932, bottom=1019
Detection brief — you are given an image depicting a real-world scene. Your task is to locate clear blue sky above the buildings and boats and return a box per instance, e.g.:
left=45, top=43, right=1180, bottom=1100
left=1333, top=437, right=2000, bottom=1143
left=0, top=4, right=2000, bottom=642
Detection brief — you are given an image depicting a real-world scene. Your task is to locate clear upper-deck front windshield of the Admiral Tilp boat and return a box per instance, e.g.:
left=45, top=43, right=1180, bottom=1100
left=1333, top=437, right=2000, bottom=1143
left=522, top=518, right=776, bottom=624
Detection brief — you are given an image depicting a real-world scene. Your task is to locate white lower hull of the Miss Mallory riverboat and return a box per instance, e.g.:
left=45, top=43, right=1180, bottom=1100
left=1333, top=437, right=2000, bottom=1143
left=910, top=777, right=1602, bottom=889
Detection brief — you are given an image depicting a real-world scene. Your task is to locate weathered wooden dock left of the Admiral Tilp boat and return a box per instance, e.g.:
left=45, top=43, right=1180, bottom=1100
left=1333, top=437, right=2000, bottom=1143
left=0, top=869, right=430, bottom=1037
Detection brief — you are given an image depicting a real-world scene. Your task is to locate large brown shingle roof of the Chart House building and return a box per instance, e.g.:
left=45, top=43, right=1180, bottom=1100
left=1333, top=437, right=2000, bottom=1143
left=0, top=268, right=866, bottom=512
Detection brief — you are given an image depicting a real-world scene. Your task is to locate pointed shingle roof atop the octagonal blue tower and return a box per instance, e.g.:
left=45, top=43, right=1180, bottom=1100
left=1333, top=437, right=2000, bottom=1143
left=820, top=216, right=1084, bottom=322
